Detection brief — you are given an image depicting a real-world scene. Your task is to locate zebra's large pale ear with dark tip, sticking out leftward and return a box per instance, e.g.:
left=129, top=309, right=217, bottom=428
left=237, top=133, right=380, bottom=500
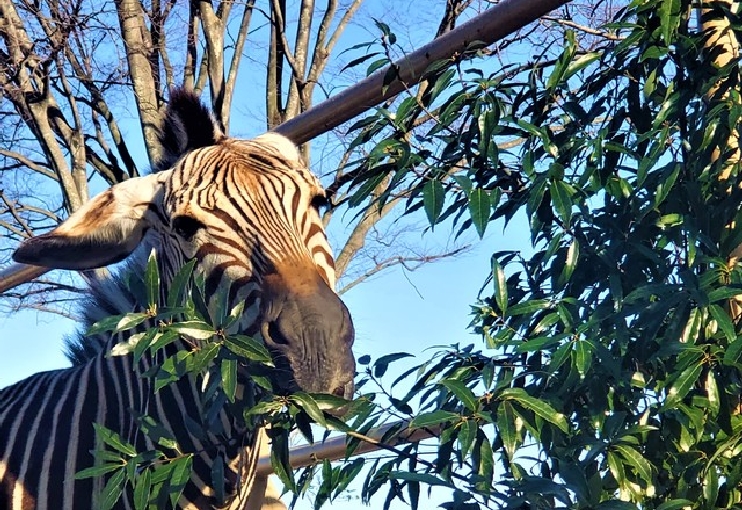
left=13, top=173, right=167, bottom=270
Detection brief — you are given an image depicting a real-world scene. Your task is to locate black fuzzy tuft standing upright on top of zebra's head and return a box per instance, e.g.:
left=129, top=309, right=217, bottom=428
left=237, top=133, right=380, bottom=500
left=155, top=88, right=224, bottom=170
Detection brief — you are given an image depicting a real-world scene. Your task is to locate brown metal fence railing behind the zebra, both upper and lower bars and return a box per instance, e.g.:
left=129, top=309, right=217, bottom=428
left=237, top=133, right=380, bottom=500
left=0, top=0, right=569, bottom=494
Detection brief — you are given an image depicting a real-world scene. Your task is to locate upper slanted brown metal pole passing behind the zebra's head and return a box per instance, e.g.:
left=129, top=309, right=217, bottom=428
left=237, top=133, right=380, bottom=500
left=0, top=0, right=569, bottom=293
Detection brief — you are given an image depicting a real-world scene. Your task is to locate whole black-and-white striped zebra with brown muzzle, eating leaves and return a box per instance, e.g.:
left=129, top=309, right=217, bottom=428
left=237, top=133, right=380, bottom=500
left=0, top=88, right=355, bottom=510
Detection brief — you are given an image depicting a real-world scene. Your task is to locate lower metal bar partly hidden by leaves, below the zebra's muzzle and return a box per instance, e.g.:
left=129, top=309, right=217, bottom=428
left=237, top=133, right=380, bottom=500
left=258, top=421, right=440, bottom=475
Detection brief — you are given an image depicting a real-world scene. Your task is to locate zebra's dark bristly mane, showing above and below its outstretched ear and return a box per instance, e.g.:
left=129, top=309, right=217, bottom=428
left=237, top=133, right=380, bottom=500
left=64, top=88, right=225, bottom=365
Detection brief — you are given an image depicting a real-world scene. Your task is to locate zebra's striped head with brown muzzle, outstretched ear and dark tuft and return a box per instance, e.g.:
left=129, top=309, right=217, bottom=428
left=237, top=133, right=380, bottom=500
left=13, top=89, right=355, bottom=397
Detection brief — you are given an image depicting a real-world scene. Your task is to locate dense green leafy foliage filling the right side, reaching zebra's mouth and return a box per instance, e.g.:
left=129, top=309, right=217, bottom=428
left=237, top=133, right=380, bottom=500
left=85, top=0, right=742, bottom=510
